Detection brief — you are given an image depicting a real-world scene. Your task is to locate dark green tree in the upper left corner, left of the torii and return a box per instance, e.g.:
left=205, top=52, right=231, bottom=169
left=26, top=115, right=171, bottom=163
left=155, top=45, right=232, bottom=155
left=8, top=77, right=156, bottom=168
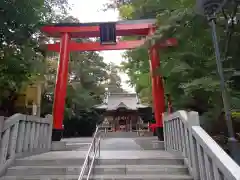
left=0, top=0, right=67, bottom=115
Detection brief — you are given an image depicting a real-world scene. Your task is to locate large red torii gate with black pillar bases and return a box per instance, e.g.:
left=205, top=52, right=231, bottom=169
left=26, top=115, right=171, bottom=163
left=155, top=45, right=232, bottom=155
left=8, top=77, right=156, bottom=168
left=41, top=19, right=177, bottom=141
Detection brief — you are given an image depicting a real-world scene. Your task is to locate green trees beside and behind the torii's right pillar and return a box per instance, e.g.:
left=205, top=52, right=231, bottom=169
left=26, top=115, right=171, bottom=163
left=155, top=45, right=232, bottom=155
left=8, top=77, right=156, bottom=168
left=107, top=0, right=240, bottom=135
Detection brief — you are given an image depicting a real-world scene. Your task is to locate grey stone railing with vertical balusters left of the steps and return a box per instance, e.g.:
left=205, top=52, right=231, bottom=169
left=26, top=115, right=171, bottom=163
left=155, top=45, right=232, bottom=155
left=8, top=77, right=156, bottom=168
left=0, top=114, right=52, bottom=176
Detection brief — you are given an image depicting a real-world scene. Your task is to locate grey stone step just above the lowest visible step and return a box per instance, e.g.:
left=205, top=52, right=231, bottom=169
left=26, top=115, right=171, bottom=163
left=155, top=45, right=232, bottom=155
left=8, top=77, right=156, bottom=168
left=6, top=165, right=188, bottom=176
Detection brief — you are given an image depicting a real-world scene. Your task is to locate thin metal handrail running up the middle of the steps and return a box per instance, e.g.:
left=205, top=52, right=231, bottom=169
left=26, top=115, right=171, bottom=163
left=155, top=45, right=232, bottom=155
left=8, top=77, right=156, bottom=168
left=78, top=126, right=101, bottom=180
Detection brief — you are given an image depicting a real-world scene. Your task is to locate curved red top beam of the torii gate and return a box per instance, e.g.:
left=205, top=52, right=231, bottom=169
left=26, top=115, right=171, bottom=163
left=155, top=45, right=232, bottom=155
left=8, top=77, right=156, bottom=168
left=41, top=19, right=156, bottom=38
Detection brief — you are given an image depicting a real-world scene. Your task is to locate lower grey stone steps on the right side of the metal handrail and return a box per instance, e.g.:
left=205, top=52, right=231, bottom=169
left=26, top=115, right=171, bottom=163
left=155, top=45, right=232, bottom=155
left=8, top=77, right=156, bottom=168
left=89, top=156, right=192, bottom=180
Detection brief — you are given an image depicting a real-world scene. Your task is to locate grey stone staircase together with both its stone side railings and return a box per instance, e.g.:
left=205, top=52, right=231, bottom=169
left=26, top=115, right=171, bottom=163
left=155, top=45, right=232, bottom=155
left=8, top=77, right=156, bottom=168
left=0, top=111, right=240, bottom=180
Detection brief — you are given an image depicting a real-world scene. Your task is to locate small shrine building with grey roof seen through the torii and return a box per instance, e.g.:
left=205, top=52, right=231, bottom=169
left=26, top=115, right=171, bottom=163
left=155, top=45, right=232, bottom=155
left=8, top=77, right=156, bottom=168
left=94, top=92, right=151, bottom=132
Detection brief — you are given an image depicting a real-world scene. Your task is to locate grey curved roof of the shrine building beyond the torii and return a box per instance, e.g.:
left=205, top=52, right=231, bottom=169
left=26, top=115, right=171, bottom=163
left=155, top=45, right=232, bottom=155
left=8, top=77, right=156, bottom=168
left=95, top=93, right=148, bottom=111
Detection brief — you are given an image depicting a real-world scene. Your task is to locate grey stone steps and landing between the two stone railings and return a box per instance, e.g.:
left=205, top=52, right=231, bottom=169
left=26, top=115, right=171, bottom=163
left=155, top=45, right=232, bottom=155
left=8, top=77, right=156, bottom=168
left=1, top=137, right=192, bottom=180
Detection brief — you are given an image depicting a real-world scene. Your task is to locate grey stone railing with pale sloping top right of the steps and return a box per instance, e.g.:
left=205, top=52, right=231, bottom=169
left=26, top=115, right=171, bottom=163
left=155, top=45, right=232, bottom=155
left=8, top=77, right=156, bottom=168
left=164, top=111, right=240, bottom=180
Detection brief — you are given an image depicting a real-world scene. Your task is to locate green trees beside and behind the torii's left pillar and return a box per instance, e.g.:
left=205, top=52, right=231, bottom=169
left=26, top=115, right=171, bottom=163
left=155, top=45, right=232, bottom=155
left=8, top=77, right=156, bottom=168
left=0, top=0, right=123, bottom=136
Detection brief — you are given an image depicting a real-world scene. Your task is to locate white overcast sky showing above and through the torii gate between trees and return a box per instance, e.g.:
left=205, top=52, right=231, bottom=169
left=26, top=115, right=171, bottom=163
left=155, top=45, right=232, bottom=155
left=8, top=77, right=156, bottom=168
left=68, top=0, right=134, bottom=92
